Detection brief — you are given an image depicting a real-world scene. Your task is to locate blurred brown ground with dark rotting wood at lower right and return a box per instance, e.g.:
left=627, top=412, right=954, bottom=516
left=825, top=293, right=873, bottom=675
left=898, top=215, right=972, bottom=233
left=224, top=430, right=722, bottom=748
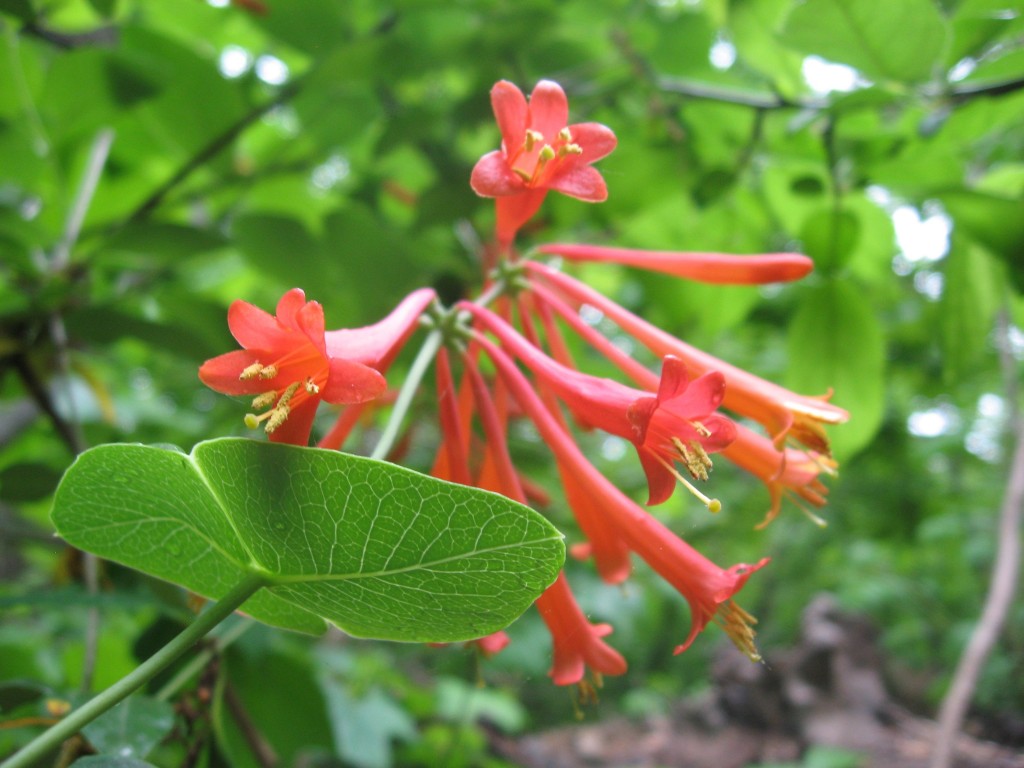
left=495, top=597, right=1024, bottom=768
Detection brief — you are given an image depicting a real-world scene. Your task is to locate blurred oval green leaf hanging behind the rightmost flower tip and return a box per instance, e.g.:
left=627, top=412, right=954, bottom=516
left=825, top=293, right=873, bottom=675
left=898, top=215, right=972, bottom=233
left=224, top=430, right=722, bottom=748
left=786, top=280, right=886, bottom=459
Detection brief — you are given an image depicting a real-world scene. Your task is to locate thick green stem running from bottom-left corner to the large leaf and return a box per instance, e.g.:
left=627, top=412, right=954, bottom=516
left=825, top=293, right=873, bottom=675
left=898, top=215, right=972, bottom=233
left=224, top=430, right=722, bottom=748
left=0, top=573, right=267, bottom=768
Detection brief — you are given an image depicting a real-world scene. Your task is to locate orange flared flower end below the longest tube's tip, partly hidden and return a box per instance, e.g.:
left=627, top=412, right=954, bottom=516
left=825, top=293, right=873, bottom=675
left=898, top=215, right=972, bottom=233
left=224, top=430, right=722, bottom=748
left=722, top=424, right=836, bottom=527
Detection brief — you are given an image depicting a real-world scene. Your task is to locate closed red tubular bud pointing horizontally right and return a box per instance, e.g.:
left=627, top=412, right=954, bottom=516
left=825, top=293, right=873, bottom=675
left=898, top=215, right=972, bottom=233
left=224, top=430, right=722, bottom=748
left=538, top=243, right=814, bottom=286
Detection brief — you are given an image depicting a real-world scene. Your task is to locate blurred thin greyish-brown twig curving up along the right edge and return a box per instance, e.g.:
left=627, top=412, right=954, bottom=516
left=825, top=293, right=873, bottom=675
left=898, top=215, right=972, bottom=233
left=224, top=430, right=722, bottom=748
left=931, top=311, right=1024, bottom=768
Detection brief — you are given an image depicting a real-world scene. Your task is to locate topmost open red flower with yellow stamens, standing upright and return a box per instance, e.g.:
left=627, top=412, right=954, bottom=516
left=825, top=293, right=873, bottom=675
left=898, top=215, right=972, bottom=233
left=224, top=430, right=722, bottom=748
left=470, top=80, right=616, bottom=244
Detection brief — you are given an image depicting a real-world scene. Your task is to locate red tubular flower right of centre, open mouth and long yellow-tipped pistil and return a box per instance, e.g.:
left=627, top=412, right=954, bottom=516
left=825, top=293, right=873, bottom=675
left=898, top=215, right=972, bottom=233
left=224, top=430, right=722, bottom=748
left=460, top=303, right=735, bottom=511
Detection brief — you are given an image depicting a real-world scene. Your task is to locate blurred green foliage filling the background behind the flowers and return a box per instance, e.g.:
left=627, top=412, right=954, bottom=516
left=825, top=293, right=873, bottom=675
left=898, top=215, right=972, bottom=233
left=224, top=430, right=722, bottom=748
left=0, top=0, right=1024, bottom=768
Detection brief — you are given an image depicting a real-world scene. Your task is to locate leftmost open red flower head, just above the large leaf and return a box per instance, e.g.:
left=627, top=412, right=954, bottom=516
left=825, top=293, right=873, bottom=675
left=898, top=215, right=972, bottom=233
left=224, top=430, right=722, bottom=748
left=199, top=288, right=386, bottom=445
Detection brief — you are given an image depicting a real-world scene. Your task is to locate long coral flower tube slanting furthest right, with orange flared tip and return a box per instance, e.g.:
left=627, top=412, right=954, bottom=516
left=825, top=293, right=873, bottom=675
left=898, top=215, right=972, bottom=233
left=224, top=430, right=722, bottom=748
left=526, top=261, right=850, bottom=456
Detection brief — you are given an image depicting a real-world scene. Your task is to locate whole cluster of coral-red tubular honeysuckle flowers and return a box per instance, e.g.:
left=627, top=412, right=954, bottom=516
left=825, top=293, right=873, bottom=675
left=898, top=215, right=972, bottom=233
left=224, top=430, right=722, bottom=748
left=200, top=80, right=848, bottom=691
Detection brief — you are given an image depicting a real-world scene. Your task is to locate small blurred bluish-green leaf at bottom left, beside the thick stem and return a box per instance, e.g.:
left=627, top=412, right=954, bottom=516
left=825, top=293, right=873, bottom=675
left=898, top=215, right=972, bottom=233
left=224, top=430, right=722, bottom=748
left=82, top=695, right=174, bottom=758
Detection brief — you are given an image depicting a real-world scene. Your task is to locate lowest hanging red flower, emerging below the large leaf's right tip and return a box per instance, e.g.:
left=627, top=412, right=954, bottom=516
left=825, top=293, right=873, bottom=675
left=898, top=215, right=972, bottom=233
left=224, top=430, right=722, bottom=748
left=537, top=573, right=626, bottom=685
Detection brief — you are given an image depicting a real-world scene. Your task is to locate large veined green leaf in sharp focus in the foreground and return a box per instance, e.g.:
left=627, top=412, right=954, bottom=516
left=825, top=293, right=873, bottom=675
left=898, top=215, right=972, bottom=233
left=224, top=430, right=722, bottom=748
left=51, top=439, right=564, bottom=642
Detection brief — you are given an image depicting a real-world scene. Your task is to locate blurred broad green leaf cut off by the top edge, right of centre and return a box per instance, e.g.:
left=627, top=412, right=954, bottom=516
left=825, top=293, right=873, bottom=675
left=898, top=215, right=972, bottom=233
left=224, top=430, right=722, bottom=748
left=780, top=0, right=946, bottom=83
